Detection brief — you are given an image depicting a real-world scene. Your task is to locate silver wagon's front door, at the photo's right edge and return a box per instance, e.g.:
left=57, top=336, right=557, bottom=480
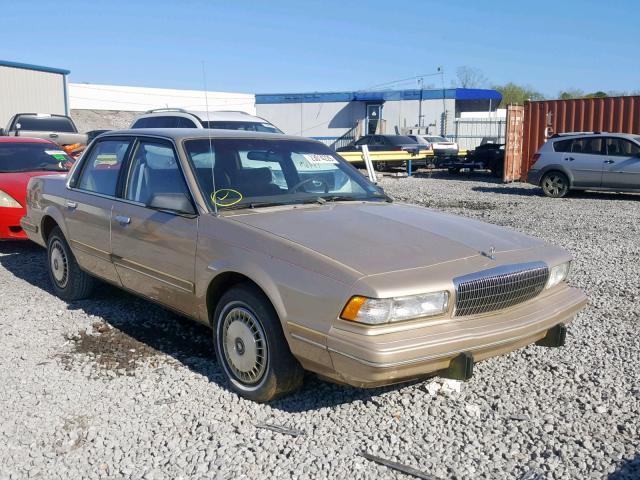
left=602, top=137, right=640, bottom=190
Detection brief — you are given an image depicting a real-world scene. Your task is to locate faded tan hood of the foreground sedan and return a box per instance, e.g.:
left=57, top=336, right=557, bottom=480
left=229, top=202, right=544, bottom=275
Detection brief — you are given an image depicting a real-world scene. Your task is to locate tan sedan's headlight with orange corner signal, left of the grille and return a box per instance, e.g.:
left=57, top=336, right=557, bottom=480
left=340, top=291, right=449, bottom=325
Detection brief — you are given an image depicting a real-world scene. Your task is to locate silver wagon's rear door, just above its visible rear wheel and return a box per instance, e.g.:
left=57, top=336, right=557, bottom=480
left=562, top=137, right=606, bottom=188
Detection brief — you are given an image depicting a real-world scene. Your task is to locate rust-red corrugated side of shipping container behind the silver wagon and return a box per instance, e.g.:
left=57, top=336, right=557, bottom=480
left=522, top=96, right=640, bottom=180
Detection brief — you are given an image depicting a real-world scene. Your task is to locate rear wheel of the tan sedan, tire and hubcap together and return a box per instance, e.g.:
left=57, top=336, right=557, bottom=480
left=47, top=227, right=94, bottom=302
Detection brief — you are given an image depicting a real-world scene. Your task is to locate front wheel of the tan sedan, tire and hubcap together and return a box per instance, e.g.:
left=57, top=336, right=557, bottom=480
left=213, top=284, right=304, bottom=402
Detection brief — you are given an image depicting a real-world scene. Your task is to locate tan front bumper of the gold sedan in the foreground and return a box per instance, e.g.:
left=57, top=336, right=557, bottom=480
left=327, top=287, right=586, bottom=387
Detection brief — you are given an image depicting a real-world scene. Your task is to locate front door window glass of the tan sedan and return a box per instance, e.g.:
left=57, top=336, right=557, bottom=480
left=124, top=141, right=189, bottom=205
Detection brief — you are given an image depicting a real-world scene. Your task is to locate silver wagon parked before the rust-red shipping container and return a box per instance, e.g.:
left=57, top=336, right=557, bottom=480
left=527, top=132, right=640, bottom=198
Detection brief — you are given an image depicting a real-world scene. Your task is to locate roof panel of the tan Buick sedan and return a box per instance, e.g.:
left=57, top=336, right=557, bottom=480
left=100, top=128, right=312, bottom=143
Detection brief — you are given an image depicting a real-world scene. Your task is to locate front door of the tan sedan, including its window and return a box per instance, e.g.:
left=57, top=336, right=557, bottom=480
left=111, top=139, right=198, bottom=316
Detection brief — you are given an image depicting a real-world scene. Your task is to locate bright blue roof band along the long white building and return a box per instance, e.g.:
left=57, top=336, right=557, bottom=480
left=256, top=88, right=502, bottom=104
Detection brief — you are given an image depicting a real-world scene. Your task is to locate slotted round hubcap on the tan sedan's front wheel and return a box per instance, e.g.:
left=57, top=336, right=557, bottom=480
left=222, top=307, right=267, bottom=384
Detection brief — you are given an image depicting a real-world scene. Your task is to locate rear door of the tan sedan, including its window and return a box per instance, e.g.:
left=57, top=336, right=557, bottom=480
left=64, top=137, right=133, bottom=284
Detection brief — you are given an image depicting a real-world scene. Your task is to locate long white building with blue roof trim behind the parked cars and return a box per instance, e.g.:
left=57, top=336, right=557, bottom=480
left=256, top=88, right=502, bottom=146
